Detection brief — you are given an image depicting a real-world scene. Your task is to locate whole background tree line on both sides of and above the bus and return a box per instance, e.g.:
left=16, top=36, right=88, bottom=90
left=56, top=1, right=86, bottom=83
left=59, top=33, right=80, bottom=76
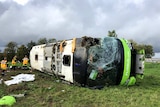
left=0, top=30, right=154, bottom=61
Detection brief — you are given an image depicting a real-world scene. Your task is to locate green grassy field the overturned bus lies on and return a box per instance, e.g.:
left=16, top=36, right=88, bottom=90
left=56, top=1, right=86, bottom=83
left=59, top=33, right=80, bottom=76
left=0, top=63, right=160, bottom=107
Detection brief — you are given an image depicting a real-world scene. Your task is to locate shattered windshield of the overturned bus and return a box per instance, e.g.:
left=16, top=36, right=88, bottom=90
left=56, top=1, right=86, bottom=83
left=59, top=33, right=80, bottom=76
left=87, top=37, right=123, bottom=85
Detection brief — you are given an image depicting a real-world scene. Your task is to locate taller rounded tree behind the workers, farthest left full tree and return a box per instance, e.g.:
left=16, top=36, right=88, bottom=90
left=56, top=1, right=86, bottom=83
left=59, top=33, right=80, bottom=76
left=3, top=41, right=17, bottom=61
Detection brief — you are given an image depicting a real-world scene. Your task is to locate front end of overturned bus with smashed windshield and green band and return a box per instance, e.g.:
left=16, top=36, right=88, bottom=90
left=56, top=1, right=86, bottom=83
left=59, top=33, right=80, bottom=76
left=87, top=37, right=144, bottom=88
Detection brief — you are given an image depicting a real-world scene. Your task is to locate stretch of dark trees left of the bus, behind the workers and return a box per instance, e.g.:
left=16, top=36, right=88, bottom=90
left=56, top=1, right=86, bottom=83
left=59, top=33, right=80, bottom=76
left=0, top=38, right=56, bottom=61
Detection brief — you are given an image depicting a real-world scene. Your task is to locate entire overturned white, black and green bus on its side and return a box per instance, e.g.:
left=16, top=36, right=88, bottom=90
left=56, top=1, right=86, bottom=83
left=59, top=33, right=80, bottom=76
left=30, top=36, right=144, bottom=87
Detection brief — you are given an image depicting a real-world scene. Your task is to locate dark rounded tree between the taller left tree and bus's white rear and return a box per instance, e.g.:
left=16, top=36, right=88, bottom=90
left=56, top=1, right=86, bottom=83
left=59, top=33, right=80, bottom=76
left=17, top=45, right=28, bottom=61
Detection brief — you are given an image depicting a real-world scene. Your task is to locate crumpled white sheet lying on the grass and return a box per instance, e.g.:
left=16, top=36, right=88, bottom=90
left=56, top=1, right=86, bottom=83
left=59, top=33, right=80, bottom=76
left=4, top=74, right=35, bottom=86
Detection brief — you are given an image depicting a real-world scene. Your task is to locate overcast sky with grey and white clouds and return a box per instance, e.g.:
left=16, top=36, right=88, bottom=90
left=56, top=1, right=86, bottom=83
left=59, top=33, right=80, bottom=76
left=0, top=0, right=160, bottom=51
